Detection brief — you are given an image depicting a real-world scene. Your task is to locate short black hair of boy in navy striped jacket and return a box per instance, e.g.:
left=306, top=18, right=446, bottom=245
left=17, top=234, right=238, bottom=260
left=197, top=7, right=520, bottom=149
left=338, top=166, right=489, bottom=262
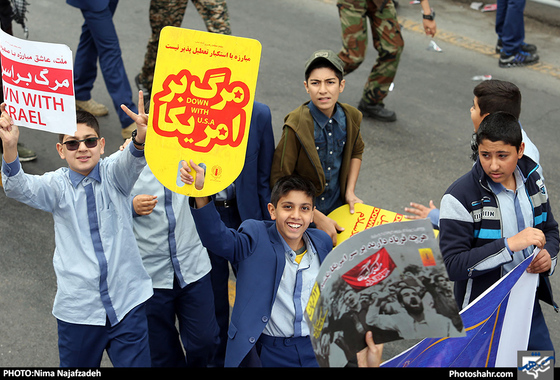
left=476, top=112, right=523, bottom=152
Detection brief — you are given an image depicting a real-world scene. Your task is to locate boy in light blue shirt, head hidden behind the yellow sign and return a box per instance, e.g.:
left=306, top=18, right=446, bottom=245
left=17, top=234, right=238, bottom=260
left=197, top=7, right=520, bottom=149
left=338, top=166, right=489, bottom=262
left=132, top=166, right=219, bottom=367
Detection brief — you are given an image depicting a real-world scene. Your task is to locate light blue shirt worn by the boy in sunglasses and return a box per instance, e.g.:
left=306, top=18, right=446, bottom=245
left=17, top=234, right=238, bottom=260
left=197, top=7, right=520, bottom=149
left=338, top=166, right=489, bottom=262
left=2, top=144, right=153, bottom=326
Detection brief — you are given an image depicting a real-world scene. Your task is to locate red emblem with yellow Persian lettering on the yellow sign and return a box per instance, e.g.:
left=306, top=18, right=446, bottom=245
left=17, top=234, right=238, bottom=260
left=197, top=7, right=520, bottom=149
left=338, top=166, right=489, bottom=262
left=152, top=67, right=250, bottom=152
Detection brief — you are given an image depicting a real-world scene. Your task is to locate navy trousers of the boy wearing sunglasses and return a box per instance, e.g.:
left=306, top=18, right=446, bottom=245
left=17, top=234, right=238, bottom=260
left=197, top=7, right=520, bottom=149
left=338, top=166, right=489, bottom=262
left=57, top=304, right=151, bottom=368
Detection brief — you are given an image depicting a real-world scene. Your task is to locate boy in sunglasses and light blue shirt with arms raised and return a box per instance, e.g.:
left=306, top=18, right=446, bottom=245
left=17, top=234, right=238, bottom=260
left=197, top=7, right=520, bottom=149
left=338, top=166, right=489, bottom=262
left=0, top=93, right=152, bottom=367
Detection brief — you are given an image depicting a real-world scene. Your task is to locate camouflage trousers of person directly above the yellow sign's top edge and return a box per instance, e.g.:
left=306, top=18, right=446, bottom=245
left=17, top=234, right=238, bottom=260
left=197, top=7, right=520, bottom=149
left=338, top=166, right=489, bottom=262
left=138, top=0, right=231, bottom=91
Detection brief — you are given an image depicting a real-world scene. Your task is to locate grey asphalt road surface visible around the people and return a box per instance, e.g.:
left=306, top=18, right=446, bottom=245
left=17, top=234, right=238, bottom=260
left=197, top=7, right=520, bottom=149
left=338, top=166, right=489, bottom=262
left=0, top=0, right=560, bottom=367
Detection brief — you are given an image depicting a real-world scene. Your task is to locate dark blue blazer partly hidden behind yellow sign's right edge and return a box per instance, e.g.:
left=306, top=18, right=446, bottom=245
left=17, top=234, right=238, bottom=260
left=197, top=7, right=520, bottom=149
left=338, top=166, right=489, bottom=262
left=234, top=102, right=275, bottom=220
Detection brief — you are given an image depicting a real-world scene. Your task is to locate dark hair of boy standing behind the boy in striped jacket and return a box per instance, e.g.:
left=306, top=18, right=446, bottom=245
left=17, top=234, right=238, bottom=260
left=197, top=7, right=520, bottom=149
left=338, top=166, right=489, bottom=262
left=473, top=79, right=521, bottom=119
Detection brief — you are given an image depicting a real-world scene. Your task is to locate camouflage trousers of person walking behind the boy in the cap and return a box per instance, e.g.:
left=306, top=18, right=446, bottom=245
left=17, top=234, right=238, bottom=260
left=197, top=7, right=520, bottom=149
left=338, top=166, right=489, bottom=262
left=337, top=0, right=404, bottom=104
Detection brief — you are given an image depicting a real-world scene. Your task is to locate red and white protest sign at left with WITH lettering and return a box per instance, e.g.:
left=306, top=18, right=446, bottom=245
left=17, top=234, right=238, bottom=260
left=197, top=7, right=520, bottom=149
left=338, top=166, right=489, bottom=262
left=0, top=31, right=76, bottom=135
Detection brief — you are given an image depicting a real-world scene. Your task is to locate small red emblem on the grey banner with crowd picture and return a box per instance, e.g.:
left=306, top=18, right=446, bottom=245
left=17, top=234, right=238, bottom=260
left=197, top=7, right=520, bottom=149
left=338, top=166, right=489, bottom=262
left=342, top=248, right=396, bottom=291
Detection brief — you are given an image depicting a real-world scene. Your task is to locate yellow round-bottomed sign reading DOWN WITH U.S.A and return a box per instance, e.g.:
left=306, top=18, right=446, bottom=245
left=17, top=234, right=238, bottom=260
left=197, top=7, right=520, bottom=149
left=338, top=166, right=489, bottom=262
left=145, top=27, right=261, bottom=196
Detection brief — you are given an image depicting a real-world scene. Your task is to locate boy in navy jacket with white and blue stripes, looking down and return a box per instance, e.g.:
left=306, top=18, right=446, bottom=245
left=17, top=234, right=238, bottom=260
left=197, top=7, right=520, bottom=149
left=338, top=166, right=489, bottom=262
left=439, top=112, right=559, bottom=350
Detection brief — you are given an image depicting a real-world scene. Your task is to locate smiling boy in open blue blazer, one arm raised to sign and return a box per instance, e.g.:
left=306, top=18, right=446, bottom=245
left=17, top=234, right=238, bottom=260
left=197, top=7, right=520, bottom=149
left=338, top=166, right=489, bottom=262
left=181, top=165, right=332, bottom=367
